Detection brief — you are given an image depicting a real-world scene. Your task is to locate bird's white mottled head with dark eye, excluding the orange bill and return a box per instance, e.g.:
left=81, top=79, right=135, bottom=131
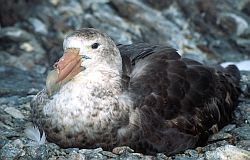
left=63, top=28, right=122, bottom=71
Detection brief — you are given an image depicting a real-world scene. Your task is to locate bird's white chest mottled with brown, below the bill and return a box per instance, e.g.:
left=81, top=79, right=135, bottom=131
left=43, top=80, right=117, bottom=138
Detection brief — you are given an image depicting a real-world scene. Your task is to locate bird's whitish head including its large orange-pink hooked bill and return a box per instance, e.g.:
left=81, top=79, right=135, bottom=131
left=46, top=28, right=122, bottom=95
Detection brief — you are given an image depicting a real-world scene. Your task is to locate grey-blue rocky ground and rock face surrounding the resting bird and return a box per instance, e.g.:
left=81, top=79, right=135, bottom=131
left=0, top=0, right=250, bottom=160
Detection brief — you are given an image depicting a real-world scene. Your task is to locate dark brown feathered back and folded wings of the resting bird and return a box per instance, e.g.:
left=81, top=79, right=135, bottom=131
left=118, top=43, right=240, bottom=154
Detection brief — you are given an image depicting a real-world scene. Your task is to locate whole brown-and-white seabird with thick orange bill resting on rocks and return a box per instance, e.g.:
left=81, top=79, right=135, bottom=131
left=31, top=28, right=240, bottom=155
